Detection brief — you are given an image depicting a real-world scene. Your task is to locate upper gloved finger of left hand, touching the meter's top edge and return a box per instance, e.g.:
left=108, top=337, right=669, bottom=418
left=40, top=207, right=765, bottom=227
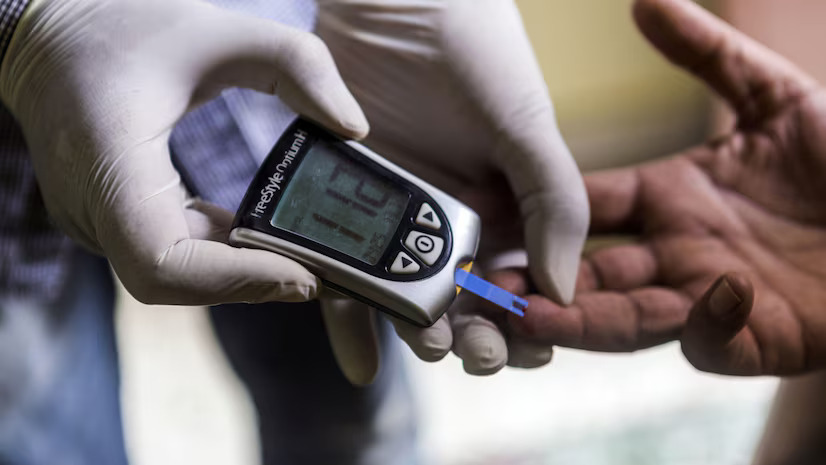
left=193, top=10, right=369, bottom=139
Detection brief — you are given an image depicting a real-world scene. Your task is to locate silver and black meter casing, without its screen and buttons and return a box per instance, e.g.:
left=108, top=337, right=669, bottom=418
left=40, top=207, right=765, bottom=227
left=230, top=119, right=481, bottom=326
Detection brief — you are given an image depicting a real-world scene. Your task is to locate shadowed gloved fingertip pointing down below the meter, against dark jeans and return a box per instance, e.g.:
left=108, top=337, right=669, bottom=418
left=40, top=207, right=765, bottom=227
left=321, top=292, right=381, bottom=386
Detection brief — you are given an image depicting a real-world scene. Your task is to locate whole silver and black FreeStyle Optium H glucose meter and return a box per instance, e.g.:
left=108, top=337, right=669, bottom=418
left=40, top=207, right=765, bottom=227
left=230, top=119, right=480, bottom=326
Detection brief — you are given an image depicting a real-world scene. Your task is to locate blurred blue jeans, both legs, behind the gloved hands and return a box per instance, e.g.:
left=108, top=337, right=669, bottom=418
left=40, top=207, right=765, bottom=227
left=0, top=254, right=416, bottom=465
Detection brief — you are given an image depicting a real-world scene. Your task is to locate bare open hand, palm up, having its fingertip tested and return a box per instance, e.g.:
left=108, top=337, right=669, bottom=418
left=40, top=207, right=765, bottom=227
left=488, top=0, right=826, bottom=375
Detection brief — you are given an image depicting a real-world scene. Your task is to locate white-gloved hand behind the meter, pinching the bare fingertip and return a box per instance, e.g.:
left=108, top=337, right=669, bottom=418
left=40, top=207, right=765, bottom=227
left=317, top=0, right=589, bottom=382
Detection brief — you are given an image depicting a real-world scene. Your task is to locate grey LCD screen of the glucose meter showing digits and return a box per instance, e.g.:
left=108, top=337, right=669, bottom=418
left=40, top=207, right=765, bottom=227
left=272, top=142, right=409, bottom=265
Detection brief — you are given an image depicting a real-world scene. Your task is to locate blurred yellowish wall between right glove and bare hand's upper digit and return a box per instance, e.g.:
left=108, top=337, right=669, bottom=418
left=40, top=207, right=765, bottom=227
left=517, top=0, right=716, bottom=170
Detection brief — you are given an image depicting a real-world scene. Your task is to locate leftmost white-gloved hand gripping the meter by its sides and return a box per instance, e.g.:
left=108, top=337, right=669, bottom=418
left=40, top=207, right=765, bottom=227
left=0, top=0, right=368, bottom=305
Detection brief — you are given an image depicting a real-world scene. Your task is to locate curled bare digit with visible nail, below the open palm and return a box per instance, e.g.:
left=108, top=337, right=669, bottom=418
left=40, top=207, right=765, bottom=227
left=681, top=273, right=762, bottom=375
